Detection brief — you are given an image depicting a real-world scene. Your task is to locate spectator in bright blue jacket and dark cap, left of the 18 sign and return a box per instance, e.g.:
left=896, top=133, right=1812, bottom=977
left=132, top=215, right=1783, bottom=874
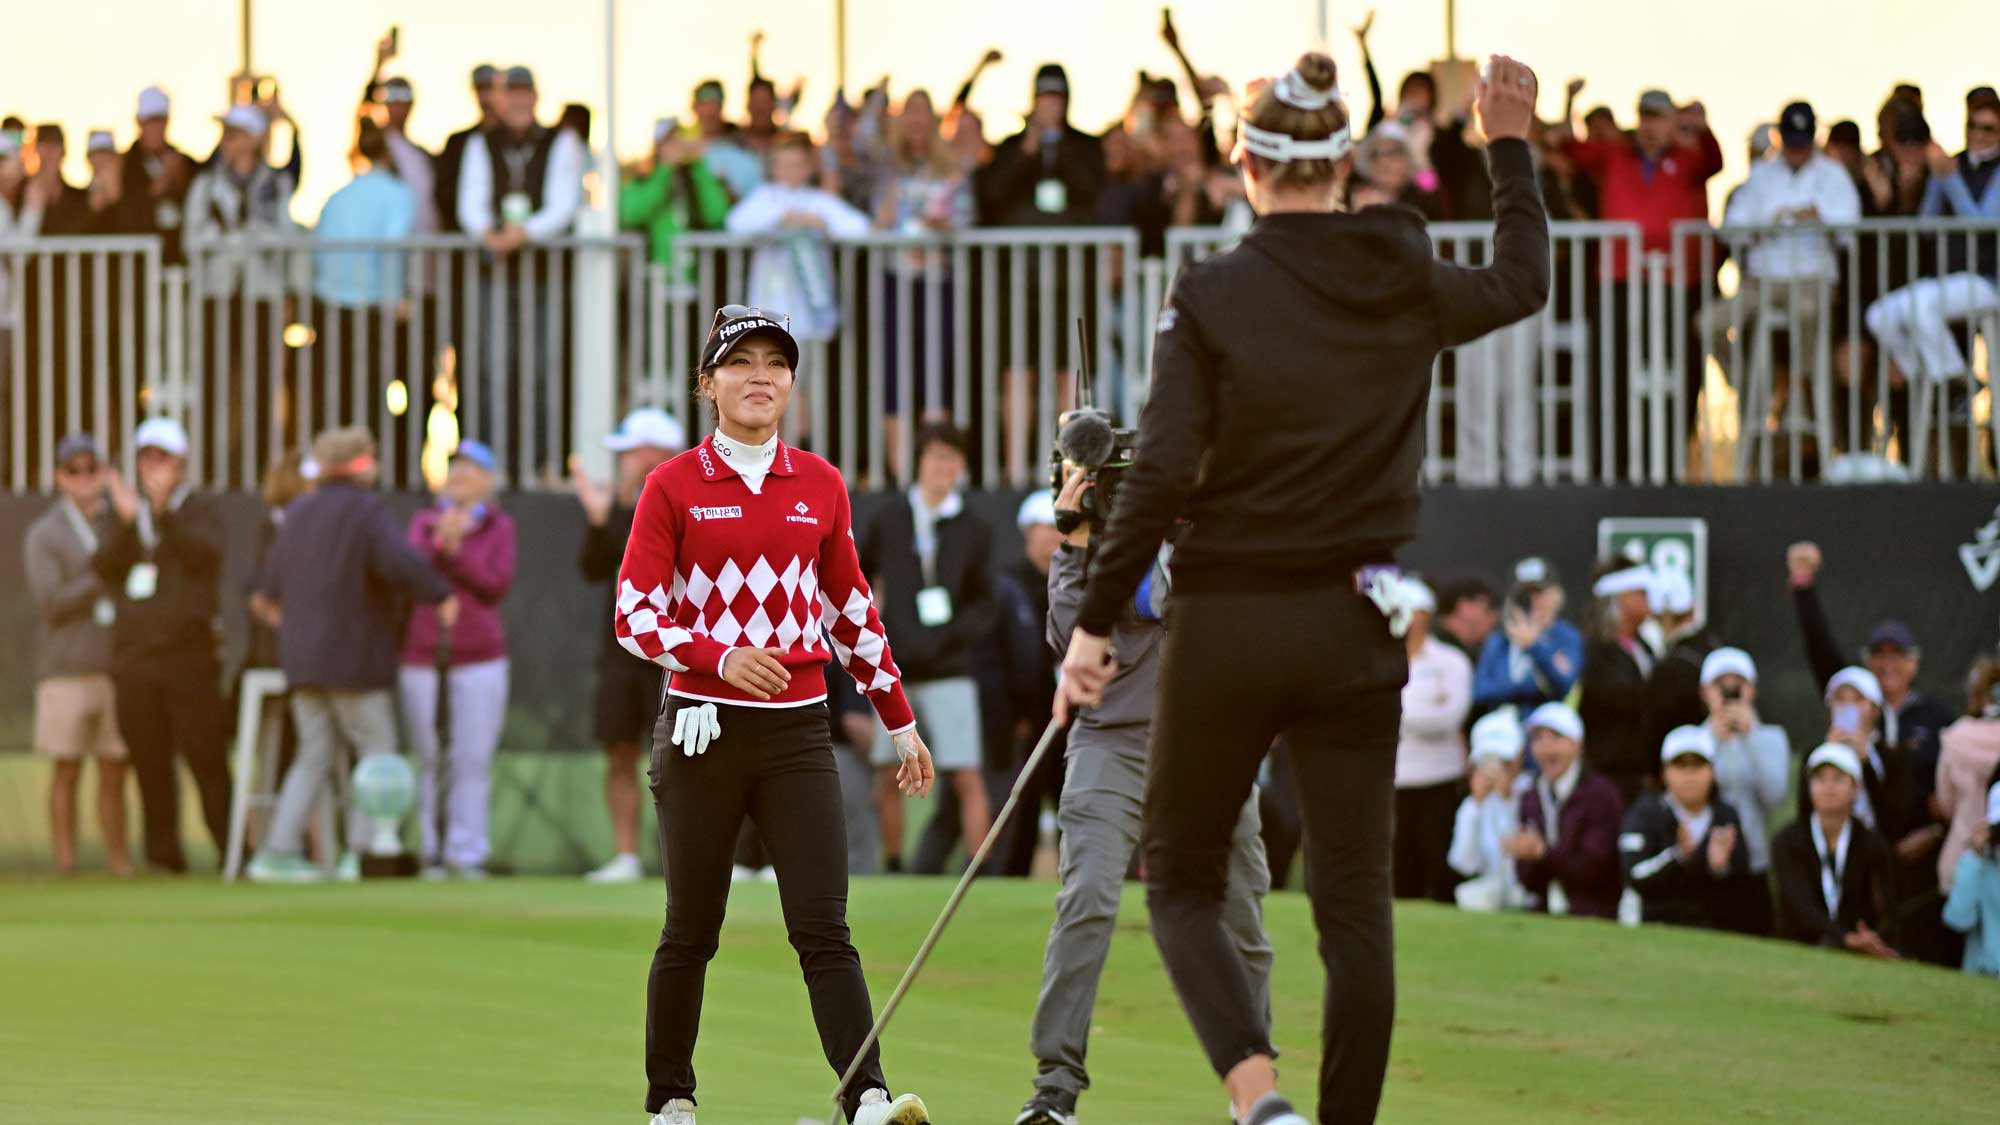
left=1472, top=558, right=1584, bottom=715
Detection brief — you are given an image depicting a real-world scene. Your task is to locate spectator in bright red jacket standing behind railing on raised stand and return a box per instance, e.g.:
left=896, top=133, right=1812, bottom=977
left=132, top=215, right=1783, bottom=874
left=1558, top=90, right=1722, bottom=480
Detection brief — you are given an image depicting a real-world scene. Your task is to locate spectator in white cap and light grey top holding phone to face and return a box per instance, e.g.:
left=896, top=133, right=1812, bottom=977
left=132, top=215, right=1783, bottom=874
left=1702, top=649, right=1792, bottom=935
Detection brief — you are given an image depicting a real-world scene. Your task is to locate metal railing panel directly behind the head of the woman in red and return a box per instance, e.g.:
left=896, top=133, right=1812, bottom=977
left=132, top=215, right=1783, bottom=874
left=660, top=228, right=1152, bottom=486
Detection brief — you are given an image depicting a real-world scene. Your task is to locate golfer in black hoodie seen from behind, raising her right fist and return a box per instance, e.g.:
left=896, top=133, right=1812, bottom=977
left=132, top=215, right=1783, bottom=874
left=1056, top=54, right=1548, bottom=1125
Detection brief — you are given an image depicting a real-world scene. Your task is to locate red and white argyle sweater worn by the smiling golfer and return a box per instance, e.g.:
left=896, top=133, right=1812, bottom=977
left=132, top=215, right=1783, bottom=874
left=614, top=436, right=916, bottom=735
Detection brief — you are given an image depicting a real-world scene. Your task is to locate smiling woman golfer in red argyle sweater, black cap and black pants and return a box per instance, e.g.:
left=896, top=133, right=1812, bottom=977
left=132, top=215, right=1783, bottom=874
left=614, top=304, right=934, bottom=1125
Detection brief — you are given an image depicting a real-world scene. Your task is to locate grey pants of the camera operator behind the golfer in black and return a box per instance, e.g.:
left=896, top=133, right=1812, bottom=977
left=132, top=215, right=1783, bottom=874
left=1030, top=727, right=1272, bottom=1095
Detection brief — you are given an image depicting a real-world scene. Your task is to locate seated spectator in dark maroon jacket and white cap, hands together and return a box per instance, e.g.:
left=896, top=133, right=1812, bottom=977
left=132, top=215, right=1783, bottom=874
left=1504, top=703, right=1624, bottom=919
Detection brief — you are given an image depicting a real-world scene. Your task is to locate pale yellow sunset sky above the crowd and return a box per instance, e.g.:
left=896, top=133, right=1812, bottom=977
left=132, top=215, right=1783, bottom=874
left=0, top=0, right=2000, bottom=222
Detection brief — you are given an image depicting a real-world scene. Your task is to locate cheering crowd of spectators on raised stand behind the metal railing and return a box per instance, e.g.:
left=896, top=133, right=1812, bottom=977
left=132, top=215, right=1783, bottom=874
left=11, top=14, right=2000, bottom=476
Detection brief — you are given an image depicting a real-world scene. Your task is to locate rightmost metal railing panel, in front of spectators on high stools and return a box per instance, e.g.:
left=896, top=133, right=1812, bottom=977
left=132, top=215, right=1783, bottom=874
left=1654, top=218, right=2000, bottom=480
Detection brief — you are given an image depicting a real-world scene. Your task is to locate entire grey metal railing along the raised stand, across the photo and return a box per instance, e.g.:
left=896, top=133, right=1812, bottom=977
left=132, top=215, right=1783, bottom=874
left=0, top=220, right=2000, bottom=490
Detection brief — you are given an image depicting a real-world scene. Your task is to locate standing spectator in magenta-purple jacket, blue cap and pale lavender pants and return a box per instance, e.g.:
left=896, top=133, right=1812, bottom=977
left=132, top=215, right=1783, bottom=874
left=402, top=440, right=514, bottom=879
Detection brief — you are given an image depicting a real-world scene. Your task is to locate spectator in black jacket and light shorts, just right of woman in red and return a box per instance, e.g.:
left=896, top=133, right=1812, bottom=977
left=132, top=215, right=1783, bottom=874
left=858, top=422, right=994, bottom=871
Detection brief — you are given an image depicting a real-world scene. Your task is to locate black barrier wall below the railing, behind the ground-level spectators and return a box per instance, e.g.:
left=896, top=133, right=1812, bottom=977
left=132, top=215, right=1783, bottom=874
left=0, top=484, right=2000, bottom=751
